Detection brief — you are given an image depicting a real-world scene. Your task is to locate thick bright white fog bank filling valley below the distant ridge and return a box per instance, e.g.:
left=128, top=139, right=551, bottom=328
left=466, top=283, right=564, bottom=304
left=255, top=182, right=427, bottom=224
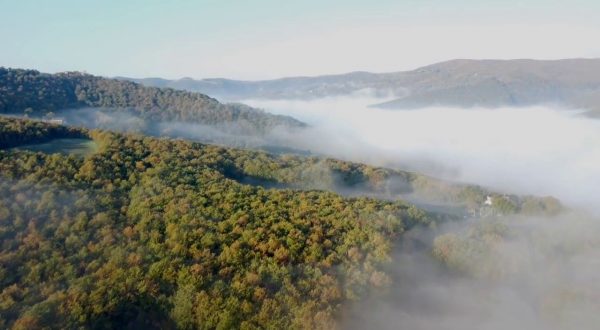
left=245, top=97, right=600, bottom=211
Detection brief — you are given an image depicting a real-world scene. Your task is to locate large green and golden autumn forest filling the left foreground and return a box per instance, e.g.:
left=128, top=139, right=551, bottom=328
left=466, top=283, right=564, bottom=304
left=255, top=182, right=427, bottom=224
left=0, top=119, right=432, bottom=329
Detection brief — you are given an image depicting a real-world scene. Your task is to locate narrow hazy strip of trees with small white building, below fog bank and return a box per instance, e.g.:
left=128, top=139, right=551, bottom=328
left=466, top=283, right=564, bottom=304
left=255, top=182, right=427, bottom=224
left=206, top=144, right=563, bottom=217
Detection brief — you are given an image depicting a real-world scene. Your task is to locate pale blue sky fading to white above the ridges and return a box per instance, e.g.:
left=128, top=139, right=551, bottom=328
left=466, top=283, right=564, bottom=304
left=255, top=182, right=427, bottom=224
left=0, top=0, right=600, bottom=79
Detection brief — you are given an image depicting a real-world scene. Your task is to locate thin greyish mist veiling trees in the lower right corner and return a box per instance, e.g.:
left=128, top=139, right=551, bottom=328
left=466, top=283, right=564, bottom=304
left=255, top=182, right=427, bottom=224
left=344, top=214, right=600, bottom=330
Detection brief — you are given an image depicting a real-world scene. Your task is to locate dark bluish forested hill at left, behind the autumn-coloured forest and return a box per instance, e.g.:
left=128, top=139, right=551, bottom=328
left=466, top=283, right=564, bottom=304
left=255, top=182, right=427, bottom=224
left=0, top=68, right=304, bottom=132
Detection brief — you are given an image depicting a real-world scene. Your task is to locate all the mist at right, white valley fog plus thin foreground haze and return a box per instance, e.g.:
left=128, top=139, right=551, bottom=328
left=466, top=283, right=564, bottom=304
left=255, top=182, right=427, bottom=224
left=238, top=97, right=600, bottom=330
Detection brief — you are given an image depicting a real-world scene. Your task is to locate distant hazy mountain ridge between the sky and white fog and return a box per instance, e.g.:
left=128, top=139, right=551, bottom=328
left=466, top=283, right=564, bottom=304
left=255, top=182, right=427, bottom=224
left=120, top=59, right=600, bottom=113
